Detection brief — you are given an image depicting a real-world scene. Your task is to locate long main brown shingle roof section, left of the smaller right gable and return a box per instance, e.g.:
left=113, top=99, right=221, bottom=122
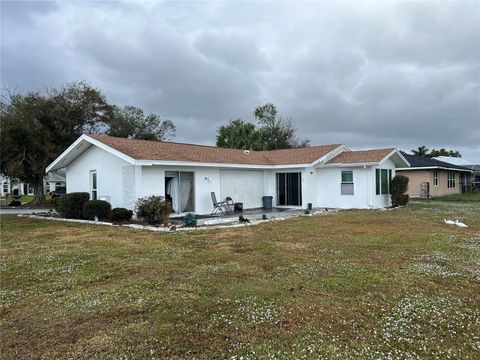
left=89, top=135, right=340, bottom=165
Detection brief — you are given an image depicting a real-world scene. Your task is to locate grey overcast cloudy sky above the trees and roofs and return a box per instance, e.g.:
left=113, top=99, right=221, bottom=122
left=1, top=0, right=480, bottom=160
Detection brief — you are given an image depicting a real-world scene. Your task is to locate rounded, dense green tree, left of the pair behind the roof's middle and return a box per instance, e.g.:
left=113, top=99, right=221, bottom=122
left=216, top=119, right=262, bottom=150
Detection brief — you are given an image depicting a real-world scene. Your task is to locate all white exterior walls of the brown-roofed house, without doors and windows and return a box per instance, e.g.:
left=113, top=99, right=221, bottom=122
left=62, top=146, right=395, bottom=214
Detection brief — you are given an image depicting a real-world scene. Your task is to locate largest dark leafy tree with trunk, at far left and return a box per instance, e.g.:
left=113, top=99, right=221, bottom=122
left=0, top=82, right=112, bottom=203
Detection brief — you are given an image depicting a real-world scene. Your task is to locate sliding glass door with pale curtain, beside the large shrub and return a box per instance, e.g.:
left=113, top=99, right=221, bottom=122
left=165, top=171, right=195, bottom=213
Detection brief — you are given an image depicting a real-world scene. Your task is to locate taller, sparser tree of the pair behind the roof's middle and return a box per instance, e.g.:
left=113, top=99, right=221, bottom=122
left=253, top=103, right=309, bottom=150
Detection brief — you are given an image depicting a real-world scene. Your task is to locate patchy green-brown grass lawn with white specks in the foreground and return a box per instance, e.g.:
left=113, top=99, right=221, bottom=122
left=0, top=201, right=480, bottom=359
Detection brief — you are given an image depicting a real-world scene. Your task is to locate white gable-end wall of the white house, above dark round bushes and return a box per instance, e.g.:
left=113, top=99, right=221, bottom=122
left=66, top=146, right=131, bottom=208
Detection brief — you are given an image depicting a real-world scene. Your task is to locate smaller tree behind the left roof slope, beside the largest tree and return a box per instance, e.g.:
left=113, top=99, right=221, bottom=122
left=107, top=106, right=176, bottom=141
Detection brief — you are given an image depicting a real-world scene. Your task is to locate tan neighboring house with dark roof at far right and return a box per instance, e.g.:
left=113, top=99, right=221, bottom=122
left=397, top=155, right=472, bottom=198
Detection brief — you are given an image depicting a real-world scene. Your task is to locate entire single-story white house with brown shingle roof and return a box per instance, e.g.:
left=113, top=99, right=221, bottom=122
left=46, top=135, right=408, bottom=214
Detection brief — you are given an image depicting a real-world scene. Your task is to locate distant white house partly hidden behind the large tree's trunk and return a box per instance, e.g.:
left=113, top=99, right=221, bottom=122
left=0, top=169, right=66, bottom=196
